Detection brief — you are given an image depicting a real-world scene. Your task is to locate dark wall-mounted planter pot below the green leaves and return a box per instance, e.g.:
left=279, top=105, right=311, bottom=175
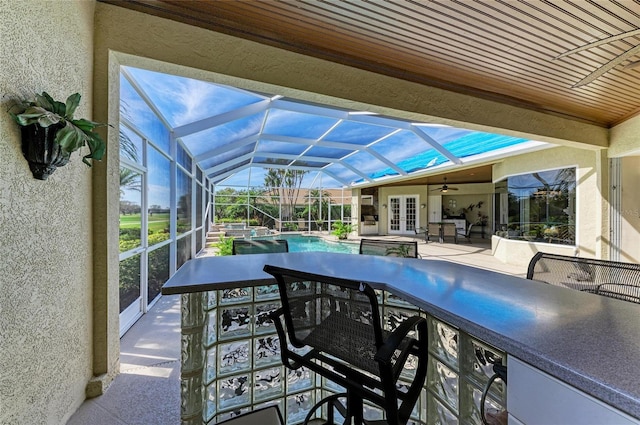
left=20, top=124, right=71, bottom=180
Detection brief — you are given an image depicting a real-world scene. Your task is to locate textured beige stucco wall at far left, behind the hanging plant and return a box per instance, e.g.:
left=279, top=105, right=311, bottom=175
left=0, top=0, right=95, bottom=425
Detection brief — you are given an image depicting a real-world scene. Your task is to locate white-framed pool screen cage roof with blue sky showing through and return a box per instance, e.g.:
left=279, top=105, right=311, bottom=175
left=121, top=67, right=546, bottom=189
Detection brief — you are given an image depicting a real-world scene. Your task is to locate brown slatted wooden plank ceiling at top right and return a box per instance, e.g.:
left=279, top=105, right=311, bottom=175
left=103, top=0, right=640, bottom=127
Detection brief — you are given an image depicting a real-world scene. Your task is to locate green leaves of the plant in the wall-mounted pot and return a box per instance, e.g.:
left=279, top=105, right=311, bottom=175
left=9, top=91, right=107, bottom=167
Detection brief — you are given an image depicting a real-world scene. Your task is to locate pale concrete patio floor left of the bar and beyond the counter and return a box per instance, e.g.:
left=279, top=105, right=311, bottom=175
left=67, top=236, right=526, bottom=425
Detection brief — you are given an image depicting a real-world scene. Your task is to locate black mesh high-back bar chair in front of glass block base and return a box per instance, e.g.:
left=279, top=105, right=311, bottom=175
left=264, top=265, right=428, bottom=425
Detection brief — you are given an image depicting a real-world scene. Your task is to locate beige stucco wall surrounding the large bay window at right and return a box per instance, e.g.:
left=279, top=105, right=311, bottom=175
left=492, top=147, right=609, bottom=265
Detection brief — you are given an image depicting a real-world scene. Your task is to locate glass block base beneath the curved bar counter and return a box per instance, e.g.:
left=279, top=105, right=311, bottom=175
left=181, top=285, right=506, bottom=425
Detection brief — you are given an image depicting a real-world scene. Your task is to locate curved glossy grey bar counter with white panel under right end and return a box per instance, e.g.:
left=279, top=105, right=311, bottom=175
left=162, top=252, right=640, bottom=424
